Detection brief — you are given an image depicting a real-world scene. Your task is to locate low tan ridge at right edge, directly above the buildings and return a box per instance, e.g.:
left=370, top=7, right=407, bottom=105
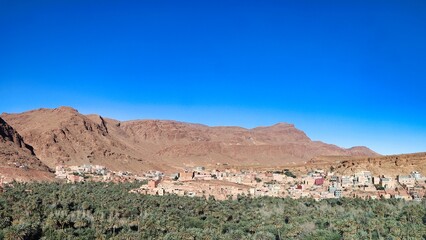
left=306, top=153, right=426, bottom=176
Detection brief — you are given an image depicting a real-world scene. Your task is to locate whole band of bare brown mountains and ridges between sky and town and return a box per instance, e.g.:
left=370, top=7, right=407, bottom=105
left=0, top=107, right=426, bottom=180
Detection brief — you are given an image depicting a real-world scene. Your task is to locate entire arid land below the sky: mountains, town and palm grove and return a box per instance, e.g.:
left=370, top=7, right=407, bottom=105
left=0, top=107, right=426, bottom=240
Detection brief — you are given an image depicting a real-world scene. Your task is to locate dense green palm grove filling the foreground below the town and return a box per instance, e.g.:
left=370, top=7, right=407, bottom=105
left=0, top=183, right=426, bottom=239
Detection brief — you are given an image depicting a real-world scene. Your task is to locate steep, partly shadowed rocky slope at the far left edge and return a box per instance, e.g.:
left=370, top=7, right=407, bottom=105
left=0, top=118, right=53, bottom=180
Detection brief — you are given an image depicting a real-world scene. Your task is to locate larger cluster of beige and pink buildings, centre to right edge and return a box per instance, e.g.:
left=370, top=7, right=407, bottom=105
left=132, top=167, right=426, bottom=201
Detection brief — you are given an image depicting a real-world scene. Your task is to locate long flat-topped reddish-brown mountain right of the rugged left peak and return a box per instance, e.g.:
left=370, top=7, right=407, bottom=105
left=120, top=120, right=377, bottom=165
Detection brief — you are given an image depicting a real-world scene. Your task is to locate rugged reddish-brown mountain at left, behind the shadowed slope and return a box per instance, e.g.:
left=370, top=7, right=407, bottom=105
left=2, top=107, right=165, bottom=171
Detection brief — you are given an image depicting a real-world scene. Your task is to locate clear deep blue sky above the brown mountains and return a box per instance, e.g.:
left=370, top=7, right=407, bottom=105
left=0, top=0, right=426, bottom=154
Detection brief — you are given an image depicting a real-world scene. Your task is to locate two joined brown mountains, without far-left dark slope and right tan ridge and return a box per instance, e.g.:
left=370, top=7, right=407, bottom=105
left=1, top=107, right=378, bottom=172
